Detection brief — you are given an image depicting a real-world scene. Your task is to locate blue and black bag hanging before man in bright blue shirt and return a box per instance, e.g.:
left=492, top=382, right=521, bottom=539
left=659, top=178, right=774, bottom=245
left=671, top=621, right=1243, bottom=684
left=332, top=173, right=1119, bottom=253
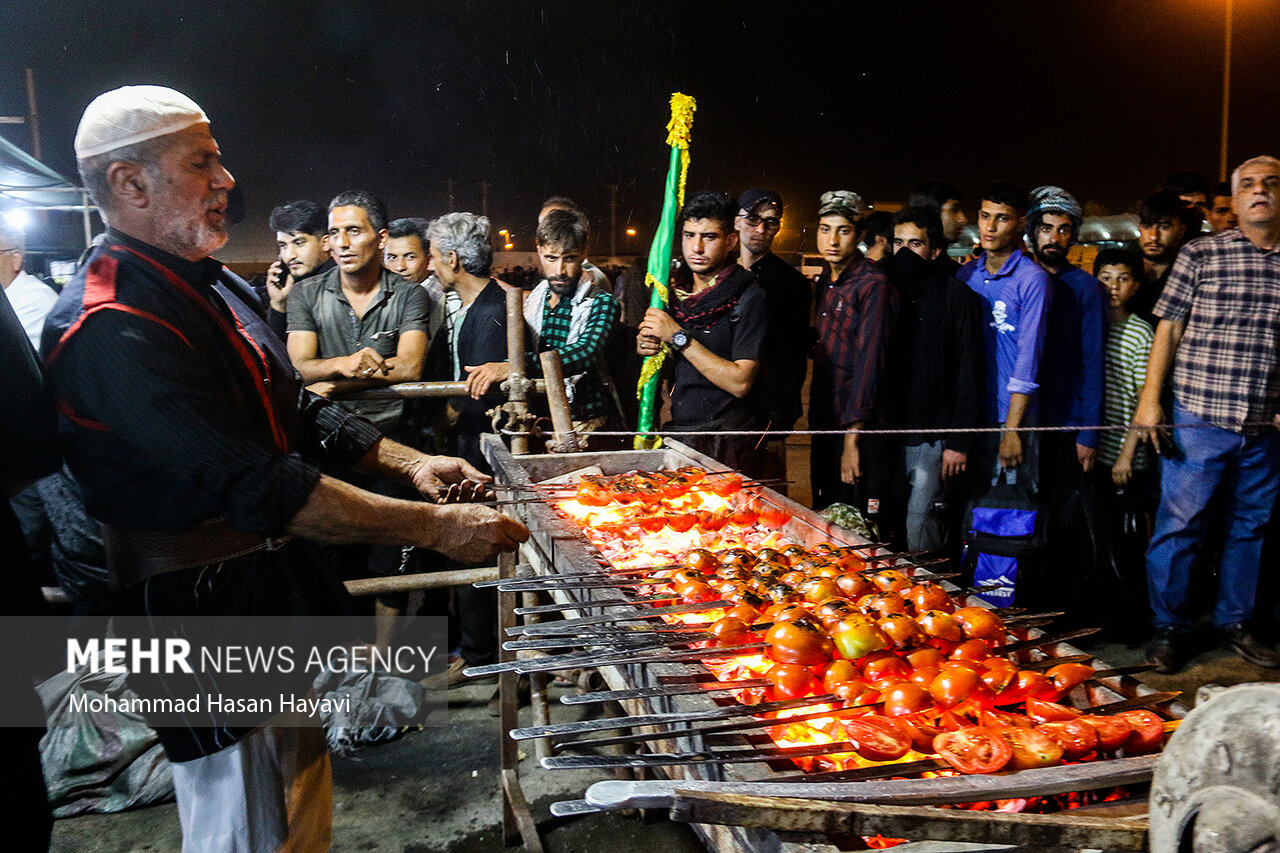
left=964, top=473, right=1048, bottom=607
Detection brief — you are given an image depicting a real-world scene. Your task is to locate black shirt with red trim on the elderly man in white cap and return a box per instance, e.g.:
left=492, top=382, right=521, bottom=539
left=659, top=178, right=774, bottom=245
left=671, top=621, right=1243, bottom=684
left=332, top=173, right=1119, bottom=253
left=44, top=231, right=379, bottom=537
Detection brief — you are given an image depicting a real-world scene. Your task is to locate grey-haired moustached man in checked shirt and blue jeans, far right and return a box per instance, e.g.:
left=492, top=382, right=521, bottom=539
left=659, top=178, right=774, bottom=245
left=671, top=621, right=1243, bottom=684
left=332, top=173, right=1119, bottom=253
left=1133, top=156, right=1280, bottom=672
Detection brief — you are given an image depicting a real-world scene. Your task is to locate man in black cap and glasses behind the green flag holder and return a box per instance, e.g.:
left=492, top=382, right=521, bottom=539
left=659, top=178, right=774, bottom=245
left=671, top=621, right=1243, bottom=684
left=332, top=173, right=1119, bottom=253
left=733, top=188, right=813, bottom=492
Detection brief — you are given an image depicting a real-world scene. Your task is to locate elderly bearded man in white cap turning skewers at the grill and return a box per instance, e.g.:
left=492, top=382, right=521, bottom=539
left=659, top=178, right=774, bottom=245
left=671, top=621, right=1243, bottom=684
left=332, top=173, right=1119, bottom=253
left=45, top=86, right=527, bottom=850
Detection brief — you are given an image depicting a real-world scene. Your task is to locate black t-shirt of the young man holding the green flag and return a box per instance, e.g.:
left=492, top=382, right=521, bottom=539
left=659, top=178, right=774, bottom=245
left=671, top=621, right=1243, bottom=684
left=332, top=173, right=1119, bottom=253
left=669, top=268, right=768, bottom=428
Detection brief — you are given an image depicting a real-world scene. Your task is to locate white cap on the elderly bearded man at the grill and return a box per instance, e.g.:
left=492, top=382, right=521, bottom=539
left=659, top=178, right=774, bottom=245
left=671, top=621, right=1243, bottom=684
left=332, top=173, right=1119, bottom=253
left=76, top=86, right=209, bottom=160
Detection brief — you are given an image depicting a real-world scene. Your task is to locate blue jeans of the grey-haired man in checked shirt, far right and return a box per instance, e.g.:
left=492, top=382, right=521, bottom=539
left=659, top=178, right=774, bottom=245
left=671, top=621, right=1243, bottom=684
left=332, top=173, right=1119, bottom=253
left=1147, top=403, right=1280, bottom=629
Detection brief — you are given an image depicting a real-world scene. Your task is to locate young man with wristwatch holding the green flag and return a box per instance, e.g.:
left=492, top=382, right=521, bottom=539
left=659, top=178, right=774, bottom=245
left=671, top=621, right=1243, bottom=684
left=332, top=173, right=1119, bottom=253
left=636, top=192, right=768, bottom=476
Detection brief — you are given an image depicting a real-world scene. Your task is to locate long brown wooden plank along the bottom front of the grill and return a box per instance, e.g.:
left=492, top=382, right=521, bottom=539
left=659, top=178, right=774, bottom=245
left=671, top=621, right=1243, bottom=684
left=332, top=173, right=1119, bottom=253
left=671, top=790, right=1147, bottom=850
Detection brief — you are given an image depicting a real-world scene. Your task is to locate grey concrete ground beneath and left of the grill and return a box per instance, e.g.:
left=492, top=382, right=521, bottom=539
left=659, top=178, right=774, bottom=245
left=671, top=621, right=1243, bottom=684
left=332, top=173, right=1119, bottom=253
left=51, top=684, right=704, bottom=853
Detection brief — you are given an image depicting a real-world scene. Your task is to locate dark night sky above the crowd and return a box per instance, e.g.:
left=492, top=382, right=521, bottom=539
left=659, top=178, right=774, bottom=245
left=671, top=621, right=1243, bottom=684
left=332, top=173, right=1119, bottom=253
left=0, top=0, right=1280, bottom=260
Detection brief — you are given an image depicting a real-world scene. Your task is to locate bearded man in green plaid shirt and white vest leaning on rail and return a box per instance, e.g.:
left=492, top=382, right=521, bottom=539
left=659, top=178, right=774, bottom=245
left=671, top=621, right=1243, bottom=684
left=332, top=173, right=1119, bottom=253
left=467, top=209, right=618, bottom=434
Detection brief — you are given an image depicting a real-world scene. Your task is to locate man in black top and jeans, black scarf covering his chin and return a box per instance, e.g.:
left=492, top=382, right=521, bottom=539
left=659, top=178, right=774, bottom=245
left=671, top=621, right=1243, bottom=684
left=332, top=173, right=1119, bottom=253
left=882, top=207, right=982, bottom=551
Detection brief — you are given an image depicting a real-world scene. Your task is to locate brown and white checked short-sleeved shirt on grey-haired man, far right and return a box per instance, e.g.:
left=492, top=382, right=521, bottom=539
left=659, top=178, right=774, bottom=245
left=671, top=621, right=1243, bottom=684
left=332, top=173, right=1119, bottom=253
left=1153, top=228, right=1280, bottom=433
